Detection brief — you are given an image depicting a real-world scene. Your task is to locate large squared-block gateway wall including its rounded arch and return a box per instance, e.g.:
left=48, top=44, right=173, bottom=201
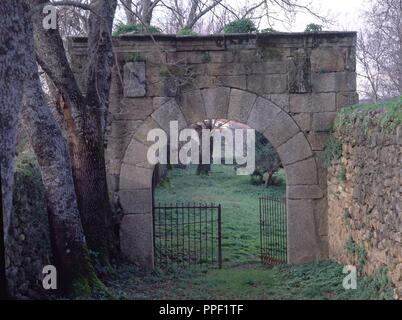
left=69, top=32, right=357, bottom=268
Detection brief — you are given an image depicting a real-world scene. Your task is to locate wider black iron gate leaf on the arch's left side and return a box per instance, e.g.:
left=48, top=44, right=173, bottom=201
left=153, top=204, right=222, bottom=269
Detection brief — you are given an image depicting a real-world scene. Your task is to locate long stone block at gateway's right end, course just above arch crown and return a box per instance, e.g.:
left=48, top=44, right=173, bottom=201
left=312, top=72, right=357, bottom=92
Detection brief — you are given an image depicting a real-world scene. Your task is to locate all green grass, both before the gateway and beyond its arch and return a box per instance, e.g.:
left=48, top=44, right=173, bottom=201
left=105, top=166, right=389, bottom=300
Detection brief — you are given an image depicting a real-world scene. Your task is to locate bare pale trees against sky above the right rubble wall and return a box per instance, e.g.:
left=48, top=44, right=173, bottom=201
left=357, top=0, right=402, bottom=101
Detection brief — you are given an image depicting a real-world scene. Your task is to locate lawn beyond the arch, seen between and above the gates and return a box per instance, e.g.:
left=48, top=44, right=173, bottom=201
left=155, top=165, right=286, bottom=265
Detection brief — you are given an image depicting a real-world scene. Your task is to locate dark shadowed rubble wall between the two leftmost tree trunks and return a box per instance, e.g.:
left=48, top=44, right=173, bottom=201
left=6, top=155, right=52, bottom=299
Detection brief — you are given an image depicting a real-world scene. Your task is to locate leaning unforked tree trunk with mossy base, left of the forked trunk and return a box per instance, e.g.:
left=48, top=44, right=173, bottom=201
left=21, top=5, right=103, bottom=295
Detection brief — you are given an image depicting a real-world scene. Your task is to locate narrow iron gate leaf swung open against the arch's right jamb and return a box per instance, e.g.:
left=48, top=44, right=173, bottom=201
left=260, top=196, right=287, bottom=265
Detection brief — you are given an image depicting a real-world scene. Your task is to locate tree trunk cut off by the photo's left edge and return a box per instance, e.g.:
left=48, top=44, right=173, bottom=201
left=0, top=0, right=26, bottom=239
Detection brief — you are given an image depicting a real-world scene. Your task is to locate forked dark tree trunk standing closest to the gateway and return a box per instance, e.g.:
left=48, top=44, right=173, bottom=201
left=29, top=0, right=117, bottom=264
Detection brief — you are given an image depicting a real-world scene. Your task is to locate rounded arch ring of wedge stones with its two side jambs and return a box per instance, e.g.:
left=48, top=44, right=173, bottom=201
left=119, top=87, right=326, bottom=268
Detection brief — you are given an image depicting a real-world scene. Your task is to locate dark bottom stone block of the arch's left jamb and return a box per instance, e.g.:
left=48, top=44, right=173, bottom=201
left=120, top=213, right=154, bottom=270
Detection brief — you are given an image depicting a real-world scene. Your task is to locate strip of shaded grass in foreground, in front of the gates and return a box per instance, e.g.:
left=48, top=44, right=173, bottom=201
left=106, top=261, right=390, bottom=300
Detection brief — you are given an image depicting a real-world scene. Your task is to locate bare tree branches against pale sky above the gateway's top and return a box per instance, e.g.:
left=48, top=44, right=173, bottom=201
left=120, top=0, right=326, bottom=34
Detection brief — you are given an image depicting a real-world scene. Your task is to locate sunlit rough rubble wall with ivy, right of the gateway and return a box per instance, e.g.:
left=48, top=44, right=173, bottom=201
left=328, top=111, right=402, bottom=298
